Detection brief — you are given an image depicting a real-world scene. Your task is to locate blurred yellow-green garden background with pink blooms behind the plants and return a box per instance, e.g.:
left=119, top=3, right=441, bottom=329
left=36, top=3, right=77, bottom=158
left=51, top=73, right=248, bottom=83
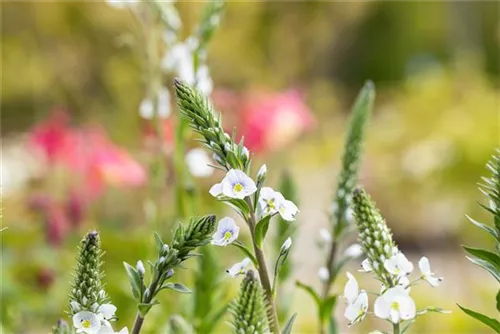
left=0, top=1, right=500, bottom=334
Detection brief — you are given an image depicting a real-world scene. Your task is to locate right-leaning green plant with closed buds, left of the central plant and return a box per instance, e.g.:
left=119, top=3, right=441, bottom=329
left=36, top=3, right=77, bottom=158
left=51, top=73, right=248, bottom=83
left=124, top=216, right=215, bottom=334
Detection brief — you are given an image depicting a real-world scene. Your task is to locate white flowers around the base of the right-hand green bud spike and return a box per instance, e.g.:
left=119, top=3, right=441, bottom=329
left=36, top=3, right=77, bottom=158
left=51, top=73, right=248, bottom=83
left=344, top=253, right=442, bottom=325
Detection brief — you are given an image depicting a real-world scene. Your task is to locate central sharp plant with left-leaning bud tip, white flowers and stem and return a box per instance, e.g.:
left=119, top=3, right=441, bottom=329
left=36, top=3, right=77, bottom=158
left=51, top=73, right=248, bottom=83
left=174, top=79, right=299, bottom=334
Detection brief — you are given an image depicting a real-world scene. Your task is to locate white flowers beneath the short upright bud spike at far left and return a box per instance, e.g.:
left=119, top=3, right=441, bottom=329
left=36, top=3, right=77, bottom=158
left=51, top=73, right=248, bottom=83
left=70, top=297, right=128, bottom=334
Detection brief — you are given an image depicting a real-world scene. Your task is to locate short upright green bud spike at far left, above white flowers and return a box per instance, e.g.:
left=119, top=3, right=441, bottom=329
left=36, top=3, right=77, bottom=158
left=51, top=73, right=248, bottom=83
left=69, top=231, right=109, bottom=315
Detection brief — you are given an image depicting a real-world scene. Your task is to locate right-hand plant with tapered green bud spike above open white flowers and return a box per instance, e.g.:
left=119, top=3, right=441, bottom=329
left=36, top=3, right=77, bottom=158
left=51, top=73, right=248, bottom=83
left=344, top=189, right=448, bottom=334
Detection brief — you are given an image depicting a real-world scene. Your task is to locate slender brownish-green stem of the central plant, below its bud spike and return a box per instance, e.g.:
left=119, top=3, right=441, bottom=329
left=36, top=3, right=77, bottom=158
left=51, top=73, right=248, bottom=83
left=246, top=198, right=280, bottom=334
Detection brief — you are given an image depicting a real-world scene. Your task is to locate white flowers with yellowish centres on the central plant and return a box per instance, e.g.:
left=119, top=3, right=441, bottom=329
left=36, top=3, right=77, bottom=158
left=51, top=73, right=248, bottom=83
left=210, top=165, right=299, bottom=277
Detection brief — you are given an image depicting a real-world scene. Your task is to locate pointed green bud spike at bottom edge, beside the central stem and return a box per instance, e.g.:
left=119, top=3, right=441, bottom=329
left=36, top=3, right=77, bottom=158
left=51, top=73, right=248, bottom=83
left=230, top=270, right=267, bottom=334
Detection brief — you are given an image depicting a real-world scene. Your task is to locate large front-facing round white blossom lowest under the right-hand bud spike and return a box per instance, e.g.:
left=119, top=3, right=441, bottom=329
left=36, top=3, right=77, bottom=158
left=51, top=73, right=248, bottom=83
left=374, top=286, right=416, bottom=324
